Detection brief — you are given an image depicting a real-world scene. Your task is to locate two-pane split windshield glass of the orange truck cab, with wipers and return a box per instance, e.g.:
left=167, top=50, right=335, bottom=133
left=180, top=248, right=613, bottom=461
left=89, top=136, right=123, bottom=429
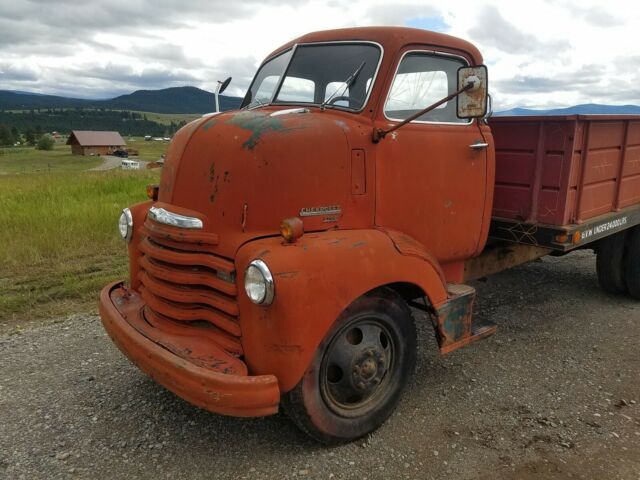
left=242, top=43, right=381, bottom=110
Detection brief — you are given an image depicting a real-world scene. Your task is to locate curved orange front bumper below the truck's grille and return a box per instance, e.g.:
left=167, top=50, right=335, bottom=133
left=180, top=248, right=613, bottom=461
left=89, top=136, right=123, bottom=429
left=100, top=282, right=280, bottom=417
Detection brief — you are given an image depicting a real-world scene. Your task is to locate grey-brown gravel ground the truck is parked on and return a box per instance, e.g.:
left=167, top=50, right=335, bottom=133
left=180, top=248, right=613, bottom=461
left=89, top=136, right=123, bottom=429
left=0, top=252, right=640, bottom=480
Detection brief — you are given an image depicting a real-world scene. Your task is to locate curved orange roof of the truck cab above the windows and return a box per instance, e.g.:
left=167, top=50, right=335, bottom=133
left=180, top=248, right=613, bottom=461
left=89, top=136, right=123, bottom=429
left=267, top=27, right=482, bottom=65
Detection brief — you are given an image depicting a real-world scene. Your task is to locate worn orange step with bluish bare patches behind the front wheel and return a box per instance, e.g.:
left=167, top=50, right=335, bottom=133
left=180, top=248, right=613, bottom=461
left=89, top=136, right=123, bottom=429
left=434, top=284, right=497, bottom=355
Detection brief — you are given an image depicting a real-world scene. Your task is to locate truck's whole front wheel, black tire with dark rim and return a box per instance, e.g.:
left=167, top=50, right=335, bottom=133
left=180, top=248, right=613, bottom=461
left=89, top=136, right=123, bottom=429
left=282, top=289, right=416, bottom=444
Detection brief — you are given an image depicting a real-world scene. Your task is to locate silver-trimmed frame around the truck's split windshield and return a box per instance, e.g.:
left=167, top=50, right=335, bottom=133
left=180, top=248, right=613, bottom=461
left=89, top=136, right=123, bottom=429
left=242, top=40, right=384, bottom=113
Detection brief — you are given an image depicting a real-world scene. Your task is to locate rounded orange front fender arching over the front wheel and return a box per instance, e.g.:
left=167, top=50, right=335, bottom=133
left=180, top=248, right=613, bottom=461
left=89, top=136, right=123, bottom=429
left=236, top=230, right=447, bottom=392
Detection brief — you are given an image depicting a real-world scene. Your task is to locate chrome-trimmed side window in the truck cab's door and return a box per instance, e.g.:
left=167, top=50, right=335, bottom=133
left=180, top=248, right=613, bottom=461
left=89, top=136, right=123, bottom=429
left=384, top=52, right=469, bottom=123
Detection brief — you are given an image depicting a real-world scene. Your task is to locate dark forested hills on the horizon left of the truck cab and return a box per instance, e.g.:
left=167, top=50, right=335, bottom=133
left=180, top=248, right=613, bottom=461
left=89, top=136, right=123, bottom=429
left=0, top=87, right=242, bottom=113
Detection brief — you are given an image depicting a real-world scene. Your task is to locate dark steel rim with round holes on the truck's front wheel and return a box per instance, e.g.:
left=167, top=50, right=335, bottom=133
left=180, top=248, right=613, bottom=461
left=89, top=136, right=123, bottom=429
left=320, top=317, right=396, bottom=417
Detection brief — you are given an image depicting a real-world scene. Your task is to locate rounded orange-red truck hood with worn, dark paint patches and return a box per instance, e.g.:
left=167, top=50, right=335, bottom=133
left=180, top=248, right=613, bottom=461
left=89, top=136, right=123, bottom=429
left=158, top=108, right=351, bottom=258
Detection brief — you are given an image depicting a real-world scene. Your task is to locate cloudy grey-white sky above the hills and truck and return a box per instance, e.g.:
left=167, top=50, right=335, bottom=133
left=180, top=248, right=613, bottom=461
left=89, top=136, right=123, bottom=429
left=0, top=0, right=640, bottom=110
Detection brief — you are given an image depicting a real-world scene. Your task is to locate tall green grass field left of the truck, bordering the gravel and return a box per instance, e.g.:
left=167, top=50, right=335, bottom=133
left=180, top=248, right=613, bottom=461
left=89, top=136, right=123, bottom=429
left=0, top=140, right=167, bottom=328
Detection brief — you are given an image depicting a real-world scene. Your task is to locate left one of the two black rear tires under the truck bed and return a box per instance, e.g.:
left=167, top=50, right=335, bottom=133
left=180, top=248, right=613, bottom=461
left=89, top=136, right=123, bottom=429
left=596, top=231, right=627, bottom=293
